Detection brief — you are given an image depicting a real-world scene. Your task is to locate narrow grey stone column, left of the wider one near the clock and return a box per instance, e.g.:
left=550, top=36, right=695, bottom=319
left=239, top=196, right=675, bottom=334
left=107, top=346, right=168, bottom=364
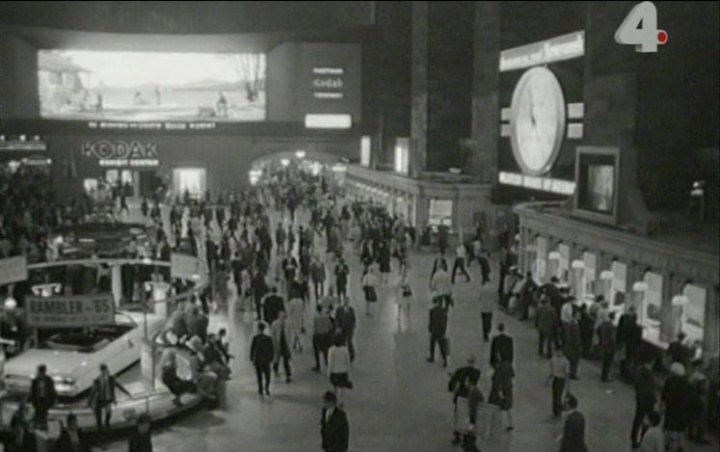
left=410, top=2, right=430, bottom=177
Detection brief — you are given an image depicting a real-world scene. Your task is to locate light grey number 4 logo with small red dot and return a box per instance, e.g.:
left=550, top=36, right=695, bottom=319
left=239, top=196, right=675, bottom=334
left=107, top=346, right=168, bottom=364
left=615, top=2, right=668, bottom=53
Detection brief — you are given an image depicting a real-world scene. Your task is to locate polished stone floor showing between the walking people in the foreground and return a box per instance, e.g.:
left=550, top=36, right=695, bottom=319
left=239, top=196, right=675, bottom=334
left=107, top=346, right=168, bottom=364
left=106, top=206, right=717, bottom=452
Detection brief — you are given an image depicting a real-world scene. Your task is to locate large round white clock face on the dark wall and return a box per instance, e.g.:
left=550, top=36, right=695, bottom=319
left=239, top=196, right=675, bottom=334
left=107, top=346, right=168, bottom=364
left=510, top=67, right=565, bottom=176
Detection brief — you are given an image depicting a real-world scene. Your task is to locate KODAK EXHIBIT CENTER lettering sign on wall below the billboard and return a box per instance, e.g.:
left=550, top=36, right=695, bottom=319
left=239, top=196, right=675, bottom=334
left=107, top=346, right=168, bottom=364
left=82, top=140, right=159, bottom=167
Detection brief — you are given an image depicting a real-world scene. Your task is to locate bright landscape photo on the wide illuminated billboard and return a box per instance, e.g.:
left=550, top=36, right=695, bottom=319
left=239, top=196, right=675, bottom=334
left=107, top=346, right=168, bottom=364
left=38, top=50, right=266, bottom=122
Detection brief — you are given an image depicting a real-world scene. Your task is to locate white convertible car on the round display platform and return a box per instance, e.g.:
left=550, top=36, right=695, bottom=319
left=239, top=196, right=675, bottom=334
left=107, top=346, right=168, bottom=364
left=3, top=312, right=165, bottom=397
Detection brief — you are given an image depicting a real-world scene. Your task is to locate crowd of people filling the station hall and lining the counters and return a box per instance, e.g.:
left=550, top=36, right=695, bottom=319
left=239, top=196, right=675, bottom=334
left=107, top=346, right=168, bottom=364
left=0, top=159, right=718, bottom=452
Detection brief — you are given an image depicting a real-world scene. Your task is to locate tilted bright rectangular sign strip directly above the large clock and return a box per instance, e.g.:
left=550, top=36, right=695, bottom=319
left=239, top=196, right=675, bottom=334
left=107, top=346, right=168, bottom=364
left=500, top=31, right=585, bottom=72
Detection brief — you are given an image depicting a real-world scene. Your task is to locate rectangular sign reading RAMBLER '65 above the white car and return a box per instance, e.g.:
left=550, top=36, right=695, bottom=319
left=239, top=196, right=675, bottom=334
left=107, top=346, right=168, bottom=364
left=25, top=294, right=115, bottom=328
